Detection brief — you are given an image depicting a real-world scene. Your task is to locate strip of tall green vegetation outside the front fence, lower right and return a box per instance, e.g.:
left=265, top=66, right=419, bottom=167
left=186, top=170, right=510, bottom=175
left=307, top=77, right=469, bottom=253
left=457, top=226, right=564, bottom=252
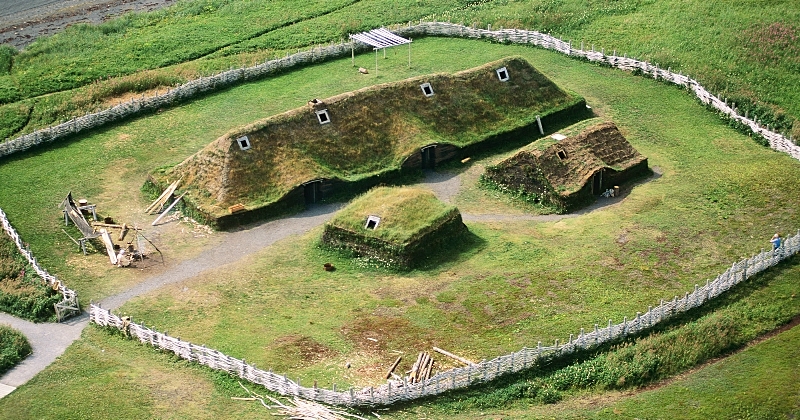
left=410, top=261, right=800, bottom=417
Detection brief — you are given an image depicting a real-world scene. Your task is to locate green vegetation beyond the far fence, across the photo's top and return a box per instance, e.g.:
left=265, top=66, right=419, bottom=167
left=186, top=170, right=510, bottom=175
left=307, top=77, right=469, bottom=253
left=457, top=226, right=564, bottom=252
left=0, top=0, right=800, bottom=144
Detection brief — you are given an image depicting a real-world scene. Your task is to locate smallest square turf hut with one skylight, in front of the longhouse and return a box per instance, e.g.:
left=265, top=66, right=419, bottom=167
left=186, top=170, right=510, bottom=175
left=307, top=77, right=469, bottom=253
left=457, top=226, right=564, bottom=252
left=322, top=187, right=467, bottom=269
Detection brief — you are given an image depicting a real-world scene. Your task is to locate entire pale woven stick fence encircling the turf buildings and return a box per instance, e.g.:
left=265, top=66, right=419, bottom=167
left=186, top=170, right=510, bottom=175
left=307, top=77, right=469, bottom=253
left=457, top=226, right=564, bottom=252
left=0, top=18, right=800, bottom=406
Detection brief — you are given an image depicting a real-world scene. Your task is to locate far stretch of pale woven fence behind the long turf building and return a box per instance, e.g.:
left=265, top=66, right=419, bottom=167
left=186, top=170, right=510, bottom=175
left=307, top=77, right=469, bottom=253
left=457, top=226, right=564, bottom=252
left=0, top=21, right=800, bottom=160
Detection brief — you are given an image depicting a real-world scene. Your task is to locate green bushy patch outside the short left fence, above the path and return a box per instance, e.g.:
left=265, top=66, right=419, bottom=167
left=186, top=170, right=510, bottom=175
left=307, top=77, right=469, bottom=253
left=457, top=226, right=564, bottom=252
left=0, top=231, right=61, bottom=321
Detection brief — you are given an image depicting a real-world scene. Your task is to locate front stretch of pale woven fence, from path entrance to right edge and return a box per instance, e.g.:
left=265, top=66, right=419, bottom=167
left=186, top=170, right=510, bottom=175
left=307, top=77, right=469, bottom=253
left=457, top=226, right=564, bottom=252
left=89, top=230, right=800, bottom=406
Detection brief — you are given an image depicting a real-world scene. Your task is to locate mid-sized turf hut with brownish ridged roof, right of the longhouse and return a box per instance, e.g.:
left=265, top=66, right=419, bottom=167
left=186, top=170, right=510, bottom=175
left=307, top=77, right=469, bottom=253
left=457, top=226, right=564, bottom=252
left=484, top=119, right=650, bottom=212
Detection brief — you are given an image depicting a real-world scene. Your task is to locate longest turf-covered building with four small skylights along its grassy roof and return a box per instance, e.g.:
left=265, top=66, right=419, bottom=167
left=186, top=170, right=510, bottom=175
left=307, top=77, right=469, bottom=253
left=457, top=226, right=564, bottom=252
left=153, top=57, right=585, bottom=225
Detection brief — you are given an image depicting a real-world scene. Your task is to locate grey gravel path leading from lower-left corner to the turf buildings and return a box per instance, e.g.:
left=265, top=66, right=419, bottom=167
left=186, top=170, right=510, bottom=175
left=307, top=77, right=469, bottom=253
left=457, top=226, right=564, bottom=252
left=0, top=167, right=661, bottom=398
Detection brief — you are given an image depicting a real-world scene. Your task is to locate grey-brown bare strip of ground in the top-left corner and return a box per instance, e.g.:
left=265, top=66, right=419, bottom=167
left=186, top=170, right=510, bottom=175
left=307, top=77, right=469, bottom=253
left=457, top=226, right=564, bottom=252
left=0, top=0, right=177, bottom=49
